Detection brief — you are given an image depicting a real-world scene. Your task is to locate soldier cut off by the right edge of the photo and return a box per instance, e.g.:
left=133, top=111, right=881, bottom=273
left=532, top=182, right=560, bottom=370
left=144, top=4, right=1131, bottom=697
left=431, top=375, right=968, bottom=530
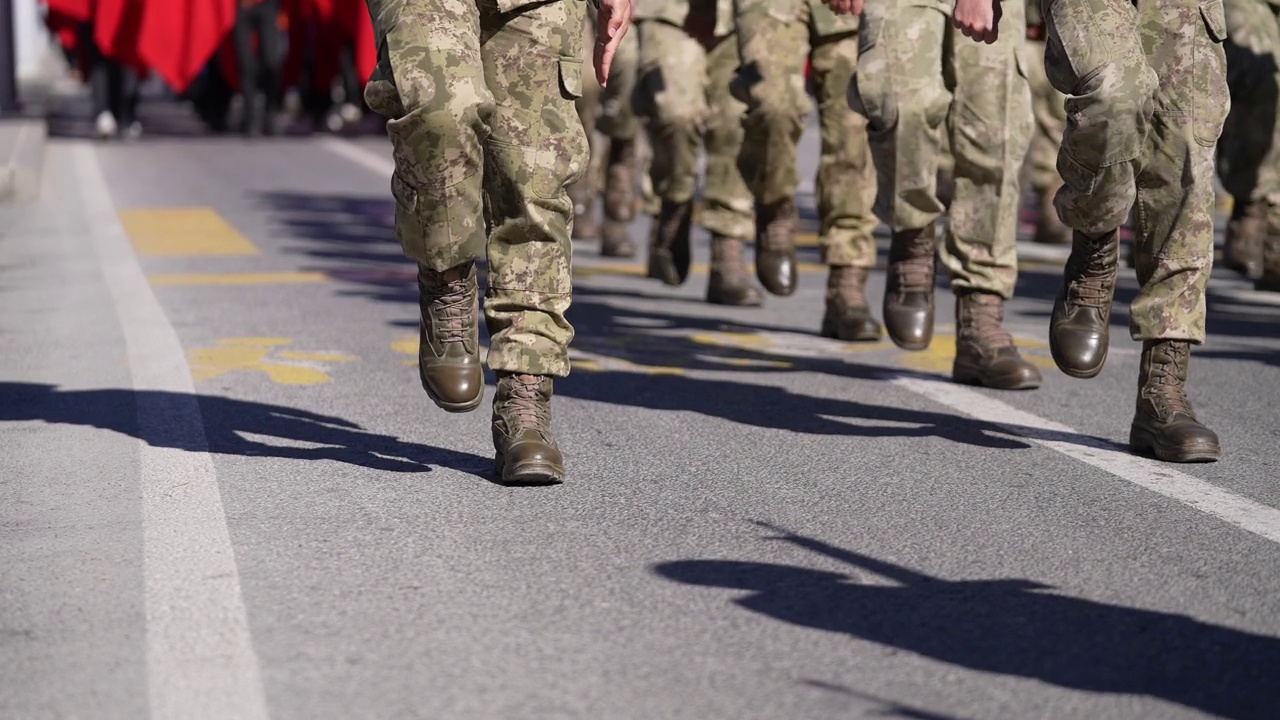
left=1219, top=0, right=1280, bottom=290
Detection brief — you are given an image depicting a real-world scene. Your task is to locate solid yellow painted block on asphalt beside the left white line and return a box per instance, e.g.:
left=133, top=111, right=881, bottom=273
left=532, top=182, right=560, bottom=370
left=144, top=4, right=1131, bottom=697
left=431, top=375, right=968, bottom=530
left=119, top=208, right=259, bottom=258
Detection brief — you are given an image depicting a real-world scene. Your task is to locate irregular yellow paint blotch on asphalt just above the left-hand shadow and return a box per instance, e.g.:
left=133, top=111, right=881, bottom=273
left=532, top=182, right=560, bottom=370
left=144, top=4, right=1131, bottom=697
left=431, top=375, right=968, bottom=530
left=187, top=337, right=356, bottom=386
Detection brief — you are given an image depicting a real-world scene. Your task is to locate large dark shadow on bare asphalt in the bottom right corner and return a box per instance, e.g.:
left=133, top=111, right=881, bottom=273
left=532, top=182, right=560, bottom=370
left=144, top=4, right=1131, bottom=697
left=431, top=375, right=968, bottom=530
left=653, top=523, right=1280, bottom=720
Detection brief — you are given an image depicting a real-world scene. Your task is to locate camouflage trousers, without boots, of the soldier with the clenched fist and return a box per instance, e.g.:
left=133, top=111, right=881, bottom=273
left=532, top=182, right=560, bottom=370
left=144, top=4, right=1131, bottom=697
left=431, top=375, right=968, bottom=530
left=849, top=0, right=1032, bottom=299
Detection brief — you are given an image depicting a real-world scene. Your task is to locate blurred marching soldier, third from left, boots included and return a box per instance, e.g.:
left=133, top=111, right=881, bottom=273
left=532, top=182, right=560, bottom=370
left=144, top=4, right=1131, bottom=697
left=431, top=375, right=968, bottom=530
left=636, top=0, right=764, bottom=306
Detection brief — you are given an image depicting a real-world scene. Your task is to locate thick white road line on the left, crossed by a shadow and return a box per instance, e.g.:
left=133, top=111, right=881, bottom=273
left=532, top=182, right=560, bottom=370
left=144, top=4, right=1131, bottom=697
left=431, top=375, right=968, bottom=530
left=74, top=145, right=268, bottom=720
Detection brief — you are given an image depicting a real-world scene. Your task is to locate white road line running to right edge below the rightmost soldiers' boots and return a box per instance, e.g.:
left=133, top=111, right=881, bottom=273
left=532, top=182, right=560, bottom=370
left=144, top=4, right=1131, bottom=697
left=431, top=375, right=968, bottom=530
left=893, top=378, right=1280, bottom=543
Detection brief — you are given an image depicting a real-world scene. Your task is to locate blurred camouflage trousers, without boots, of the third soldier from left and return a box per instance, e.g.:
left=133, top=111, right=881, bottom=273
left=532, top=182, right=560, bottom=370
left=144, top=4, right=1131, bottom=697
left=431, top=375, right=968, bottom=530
left=636, top=19, right=755, bottom=240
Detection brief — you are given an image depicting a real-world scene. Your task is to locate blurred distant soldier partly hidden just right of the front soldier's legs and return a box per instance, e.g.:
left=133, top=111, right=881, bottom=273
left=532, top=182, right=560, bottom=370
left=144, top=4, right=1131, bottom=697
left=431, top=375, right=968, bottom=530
left=568, top=9, right=640, bottom=258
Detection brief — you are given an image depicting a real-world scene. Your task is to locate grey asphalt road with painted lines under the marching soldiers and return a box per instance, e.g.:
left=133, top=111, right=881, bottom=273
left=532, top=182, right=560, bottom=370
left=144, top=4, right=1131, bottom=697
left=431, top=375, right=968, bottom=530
left=0, top=102, right=1280, bottom=720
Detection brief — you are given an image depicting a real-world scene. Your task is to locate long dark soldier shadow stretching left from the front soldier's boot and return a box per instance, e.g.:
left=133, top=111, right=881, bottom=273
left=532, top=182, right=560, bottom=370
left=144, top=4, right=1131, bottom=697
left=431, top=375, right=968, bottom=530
left=0, top=382, right=494, bottom=482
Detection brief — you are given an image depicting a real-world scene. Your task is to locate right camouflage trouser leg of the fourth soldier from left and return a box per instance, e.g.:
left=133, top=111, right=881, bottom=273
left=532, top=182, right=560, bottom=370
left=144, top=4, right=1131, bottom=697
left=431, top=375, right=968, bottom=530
left=810, top=33, right=878, bottom=268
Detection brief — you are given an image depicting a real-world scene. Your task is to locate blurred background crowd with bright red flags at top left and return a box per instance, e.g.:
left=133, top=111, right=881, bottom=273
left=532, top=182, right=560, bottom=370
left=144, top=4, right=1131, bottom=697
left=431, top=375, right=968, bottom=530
left=36, top=0, right=376, bottom=138
